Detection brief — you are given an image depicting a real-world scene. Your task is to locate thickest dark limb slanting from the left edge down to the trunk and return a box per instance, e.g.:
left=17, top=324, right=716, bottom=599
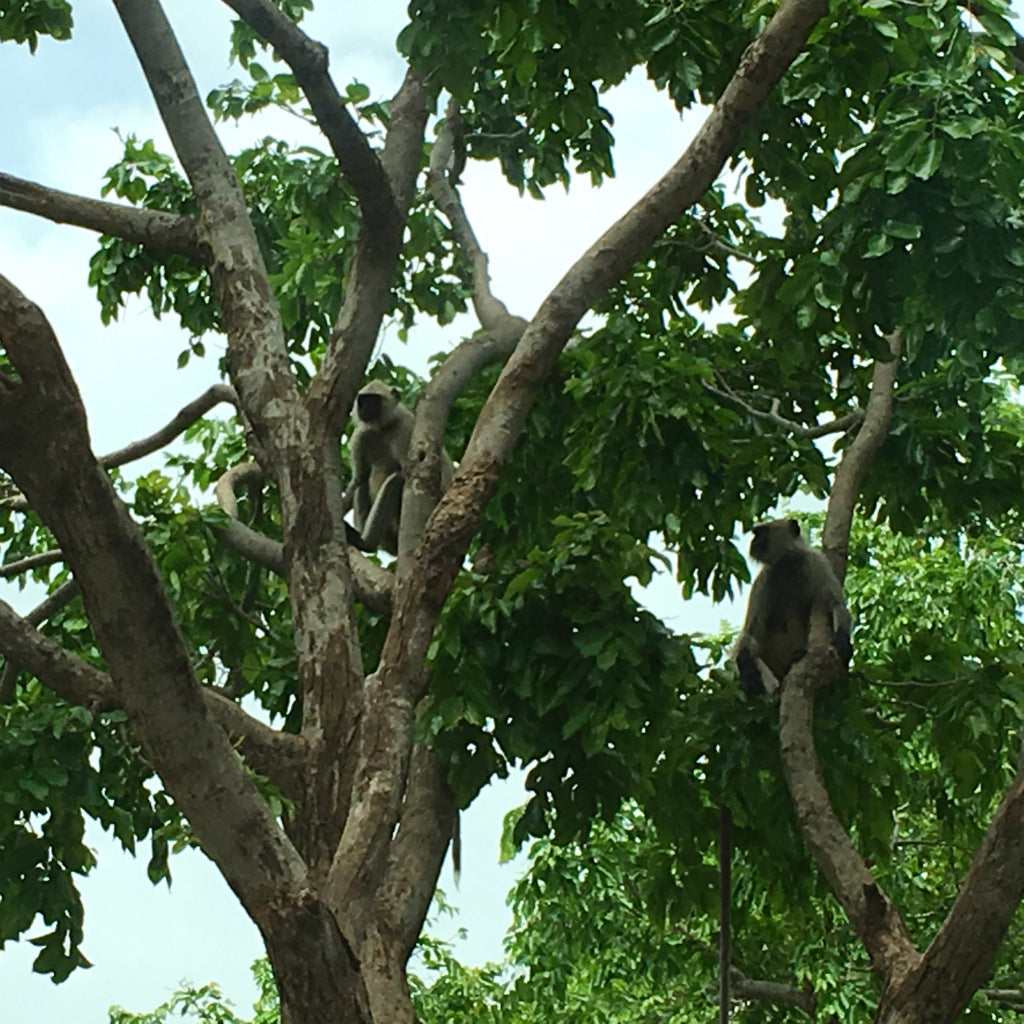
left=0, top=270, right=307, bottom=922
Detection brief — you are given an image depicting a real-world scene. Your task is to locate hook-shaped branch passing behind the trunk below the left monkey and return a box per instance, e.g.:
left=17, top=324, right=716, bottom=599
left=214, top=462, right=394, bottom=612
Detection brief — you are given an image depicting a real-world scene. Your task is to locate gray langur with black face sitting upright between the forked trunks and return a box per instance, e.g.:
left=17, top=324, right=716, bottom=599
left=348, top=381, right=455, bottom=555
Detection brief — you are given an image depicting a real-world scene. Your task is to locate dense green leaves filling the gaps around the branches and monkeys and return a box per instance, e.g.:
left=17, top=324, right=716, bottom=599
left=6, top=0, right=1024, bottom=1024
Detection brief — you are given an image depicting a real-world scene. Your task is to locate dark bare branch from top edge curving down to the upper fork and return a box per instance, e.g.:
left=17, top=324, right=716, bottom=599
left=223, top=0, right=400, bottom=234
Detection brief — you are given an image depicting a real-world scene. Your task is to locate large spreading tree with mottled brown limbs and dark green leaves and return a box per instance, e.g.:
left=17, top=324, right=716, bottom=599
left=0, top=0, right=1024, bottom=1022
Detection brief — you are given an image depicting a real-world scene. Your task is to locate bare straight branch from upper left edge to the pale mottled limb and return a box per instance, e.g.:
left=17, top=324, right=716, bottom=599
left=0, top=174, right=210, bottom=264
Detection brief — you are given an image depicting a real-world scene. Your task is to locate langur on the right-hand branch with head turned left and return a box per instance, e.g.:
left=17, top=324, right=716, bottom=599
left=734, top=519, right=853, bottom=697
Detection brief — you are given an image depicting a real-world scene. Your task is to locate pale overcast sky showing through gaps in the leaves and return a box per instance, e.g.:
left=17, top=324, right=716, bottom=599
left=0, top=0, right=719, bottom=1024
